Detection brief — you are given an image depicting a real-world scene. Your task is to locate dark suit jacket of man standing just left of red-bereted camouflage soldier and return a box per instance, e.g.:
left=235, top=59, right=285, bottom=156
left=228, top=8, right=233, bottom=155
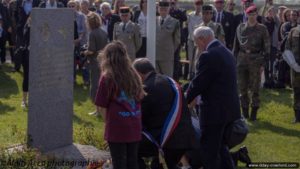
left=212, top=11, right=235, bottom=49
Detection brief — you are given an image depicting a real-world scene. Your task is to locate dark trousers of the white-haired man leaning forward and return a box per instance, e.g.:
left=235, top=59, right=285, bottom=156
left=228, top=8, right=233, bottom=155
left=200, top=124, right=235, bottom=169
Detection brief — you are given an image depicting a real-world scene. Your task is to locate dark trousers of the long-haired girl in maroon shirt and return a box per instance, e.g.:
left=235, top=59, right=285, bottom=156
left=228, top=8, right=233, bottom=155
left=108, top=142, right=139, bottom=169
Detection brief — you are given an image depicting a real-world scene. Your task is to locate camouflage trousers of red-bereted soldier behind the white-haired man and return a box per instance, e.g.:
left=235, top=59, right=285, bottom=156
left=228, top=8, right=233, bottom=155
left=237, top=62, right=261, bottom=108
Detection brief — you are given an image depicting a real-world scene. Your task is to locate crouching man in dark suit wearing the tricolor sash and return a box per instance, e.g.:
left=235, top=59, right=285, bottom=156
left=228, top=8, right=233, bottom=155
left=133, top=58, right=195, bottom=169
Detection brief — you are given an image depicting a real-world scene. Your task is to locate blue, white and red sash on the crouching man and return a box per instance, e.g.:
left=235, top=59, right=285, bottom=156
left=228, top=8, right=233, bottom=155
left=142, top=77, right=182, bottom=169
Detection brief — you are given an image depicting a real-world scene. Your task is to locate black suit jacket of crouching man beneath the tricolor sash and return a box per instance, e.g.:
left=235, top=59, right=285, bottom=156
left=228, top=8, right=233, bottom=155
left=142, top=72, right=195, bottom=149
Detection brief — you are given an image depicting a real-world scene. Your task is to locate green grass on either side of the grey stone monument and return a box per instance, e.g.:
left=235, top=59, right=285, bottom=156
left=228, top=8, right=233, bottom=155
left=0, top=65, right=104, bottom=148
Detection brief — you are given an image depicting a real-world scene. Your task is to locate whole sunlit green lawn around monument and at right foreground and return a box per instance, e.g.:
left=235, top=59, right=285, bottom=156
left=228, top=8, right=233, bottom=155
left=0, top=65, right=300, bottom=166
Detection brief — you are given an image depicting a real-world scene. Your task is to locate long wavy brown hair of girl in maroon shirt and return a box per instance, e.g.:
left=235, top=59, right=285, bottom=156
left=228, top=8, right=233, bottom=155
left=99, top=41, right=145, bottom=100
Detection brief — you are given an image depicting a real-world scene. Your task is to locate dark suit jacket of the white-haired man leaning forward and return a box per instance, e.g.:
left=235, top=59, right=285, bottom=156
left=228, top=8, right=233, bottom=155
left=187, top=41, right=241, bottom=126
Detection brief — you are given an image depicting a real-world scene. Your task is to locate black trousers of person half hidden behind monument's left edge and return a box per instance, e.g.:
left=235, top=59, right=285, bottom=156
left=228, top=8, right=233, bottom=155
left=22, top=50, right=29, bottom=92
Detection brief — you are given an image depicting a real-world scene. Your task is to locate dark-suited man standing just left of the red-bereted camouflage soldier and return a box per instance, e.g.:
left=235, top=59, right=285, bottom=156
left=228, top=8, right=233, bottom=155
left=212, top=0, right=235, bottom=49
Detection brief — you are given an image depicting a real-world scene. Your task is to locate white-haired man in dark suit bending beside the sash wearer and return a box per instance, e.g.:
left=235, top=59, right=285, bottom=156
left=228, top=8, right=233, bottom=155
left=187, top=26, right=241, bottom=169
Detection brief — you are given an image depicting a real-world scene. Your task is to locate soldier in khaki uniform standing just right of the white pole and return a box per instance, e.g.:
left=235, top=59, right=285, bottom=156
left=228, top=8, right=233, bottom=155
left=156, top=0, right=180, bottom=77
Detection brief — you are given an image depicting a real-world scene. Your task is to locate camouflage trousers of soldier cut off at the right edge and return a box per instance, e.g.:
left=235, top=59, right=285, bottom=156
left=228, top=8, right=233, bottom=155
left=291, top=70, right=300, bottom=111
